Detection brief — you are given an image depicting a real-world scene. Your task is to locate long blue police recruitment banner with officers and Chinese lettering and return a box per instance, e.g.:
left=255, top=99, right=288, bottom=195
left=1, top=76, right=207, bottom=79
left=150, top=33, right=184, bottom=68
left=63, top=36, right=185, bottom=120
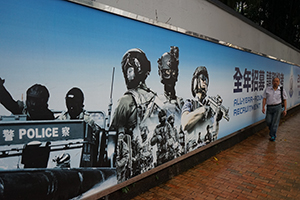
left=0, top=0, right=300, bottom=197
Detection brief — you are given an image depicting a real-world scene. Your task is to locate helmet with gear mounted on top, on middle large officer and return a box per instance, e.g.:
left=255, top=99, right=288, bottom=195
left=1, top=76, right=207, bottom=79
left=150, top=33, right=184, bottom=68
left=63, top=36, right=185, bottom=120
left=157, top=46, right=179, bottom=84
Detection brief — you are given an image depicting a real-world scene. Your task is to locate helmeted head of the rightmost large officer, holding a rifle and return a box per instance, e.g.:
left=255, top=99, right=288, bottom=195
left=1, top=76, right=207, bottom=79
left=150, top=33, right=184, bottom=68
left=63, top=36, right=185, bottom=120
left=191, top=66, right=209, bottom=97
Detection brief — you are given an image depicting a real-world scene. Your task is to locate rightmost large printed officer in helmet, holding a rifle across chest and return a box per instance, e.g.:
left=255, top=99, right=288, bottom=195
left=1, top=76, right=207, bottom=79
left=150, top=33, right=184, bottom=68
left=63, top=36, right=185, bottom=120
left=181, top=66, right=222, bottom=152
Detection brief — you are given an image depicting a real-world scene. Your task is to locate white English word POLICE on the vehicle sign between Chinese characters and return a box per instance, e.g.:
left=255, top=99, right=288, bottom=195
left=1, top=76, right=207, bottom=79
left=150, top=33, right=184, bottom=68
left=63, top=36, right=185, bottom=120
left=19, top=127, right=58, bottom=140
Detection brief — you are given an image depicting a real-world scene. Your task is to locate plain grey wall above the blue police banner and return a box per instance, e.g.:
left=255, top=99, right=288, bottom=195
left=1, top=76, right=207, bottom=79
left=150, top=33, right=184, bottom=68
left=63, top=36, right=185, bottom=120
left=96, top=0, right=300, bottom=65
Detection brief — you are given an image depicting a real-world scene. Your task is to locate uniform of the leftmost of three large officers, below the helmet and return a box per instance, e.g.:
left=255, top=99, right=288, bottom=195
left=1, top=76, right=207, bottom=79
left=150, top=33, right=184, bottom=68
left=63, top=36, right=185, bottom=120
left=111, top=84, right=155, bottom=181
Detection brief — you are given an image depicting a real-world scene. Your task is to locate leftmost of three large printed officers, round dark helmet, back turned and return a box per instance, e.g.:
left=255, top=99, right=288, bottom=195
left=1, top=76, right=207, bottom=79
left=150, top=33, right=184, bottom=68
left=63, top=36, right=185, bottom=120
left=110, top=48, right=155, bottom=182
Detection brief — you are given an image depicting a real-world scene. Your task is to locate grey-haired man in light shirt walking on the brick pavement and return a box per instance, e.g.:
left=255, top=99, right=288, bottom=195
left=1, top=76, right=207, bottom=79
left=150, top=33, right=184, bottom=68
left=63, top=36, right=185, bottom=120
left=262, top=77, right=287, bottom=141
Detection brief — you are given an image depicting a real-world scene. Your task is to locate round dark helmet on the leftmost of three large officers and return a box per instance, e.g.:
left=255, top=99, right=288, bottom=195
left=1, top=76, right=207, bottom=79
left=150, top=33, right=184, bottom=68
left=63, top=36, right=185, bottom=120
left=121, top=48, right=151, bottom=89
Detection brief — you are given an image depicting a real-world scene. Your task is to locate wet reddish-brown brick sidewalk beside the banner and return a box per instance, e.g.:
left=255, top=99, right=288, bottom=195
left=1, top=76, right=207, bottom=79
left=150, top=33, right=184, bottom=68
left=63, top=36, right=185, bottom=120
left=133, top=112, right=300, bottom=200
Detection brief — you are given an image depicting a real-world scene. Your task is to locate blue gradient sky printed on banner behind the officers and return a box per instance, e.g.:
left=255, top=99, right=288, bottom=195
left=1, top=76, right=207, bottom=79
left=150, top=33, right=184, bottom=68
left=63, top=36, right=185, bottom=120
left=0, top=0, right=300, bottom=138
